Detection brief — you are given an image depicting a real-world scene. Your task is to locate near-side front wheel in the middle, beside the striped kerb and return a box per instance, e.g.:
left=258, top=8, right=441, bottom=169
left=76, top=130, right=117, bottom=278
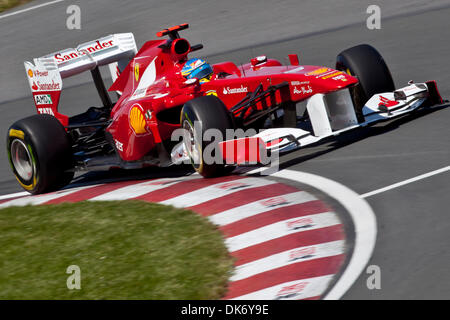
left=181, top=96, right=233, bottom=178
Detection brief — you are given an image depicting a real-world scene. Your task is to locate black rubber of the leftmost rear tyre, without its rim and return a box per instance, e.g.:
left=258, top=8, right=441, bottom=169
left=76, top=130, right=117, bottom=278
left=6, top=114, right=73, bottom=194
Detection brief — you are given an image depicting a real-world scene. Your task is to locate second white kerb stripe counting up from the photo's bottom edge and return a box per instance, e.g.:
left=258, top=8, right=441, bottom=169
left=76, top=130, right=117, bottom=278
left=230, top=240, right=345, bottom=281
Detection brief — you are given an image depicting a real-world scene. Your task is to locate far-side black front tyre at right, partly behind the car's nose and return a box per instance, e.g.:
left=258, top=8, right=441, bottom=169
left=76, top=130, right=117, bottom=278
left=336, top=44, right=395, bottom=122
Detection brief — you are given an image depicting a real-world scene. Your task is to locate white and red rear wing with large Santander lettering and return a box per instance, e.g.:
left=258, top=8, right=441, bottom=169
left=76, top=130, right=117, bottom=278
left=24, top=33, right=137, bottom=126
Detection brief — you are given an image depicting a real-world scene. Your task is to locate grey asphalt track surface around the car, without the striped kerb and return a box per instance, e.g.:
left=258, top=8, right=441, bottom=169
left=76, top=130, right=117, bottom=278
left=0, top=0, right=450, bottom=299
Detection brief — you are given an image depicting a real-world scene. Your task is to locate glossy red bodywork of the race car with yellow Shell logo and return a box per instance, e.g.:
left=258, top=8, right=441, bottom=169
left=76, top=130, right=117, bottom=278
left=106, top=28, right=358, bottom=161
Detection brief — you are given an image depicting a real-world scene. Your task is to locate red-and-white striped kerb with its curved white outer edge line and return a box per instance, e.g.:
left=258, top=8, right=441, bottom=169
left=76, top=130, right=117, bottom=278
left=0, top=170, right=376, bottom=300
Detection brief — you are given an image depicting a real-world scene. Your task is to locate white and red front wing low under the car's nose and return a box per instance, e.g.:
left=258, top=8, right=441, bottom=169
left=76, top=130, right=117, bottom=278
left=171, top=81, right=443, bottom=165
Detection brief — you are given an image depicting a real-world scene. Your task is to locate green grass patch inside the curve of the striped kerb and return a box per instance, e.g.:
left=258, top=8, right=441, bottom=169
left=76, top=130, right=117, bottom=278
left=0, top=201, right=233, bottom=300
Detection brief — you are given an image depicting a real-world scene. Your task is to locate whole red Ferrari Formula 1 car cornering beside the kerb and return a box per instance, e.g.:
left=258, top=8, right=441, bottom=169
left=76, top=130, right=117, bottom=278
left=7, top=24, right=443, bottom=194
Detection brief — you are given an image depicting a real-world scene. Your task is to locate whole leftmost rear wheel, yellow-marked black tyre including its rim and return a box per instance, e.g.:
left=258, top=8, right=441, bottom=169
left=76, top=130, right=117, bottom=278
left=6, top=114, right=74, bottom=194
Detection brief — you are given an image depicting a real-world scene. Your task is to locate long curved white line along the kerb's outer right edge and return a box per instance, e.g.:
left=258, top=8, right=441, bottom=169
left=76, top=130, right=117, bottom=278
left=272, top=170, right=377, bottom=300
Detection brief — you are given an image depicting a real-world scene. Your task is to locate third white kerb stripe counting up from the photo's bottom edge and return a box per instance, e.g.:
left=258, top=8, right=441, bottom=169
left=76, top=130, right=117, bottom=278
left=225, top=212, right=341, bottom=252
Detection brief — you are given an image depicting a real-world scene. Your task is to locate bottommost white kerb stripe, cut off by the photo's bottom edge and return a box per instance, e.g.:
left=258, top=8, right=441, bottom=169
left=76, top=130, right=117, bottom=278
left=231, top=275, right=334, bottom=302
